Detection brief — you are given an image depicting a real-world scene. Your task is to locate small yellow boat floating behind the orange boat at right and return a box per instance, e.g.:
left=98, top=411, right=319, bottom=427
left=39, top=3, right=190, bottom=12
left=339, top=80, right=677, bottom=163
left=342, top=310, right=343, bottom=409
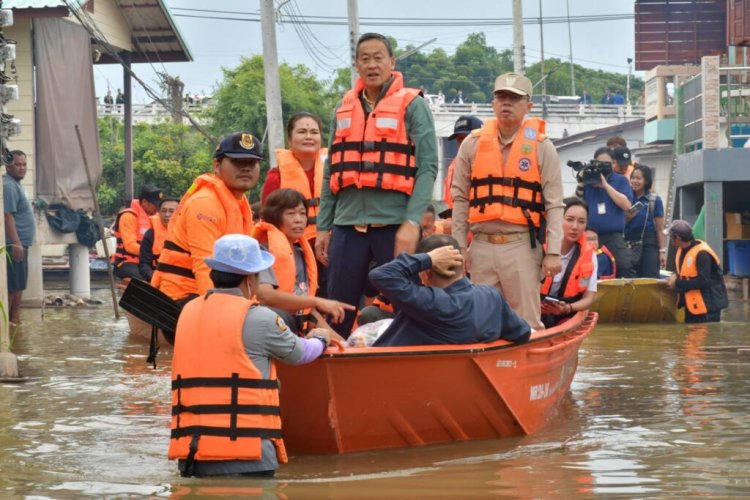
left=591, top=278, right=685, bottom=323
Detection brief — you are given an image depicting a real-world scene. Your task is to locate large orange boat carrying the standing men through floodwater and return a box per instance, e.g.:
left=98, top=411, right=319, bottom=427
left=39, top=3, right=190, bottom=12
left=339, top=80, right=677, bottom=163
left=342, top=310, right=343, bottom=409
left=277, top=312, right=597, bottom=453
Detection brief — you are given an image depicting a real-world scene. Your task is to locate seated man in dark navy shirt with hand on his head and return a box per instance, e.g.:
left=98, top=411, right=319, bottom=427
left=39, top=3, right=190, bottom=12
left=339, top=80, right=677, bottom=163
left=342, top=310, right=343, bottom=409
left=370, top=234, right=531, bottom=347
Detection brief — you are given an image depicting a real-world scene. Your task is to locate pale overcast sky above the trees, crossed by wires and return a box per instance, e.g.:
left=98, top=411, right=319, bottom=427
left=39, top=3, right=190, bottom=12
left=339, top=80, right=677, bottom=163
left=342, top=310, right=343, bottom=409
left=94, top=0, right=643, bottom=103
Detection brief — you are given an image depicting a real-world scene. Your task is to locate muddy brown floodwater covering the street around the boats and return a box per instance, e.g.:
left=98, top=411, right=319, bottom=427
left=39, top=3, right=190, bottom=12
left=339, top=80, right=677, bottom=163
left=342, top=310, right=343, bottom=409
left=0, top=289, right=750, bottom=498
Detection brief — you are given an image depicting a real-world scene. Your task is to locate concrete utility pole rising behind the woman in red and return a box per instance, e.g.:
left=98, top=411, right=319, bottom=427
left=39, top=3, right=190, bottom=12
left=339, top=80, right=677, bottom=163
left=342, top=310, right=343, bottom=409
left=256, top=0, right=284, bottom=165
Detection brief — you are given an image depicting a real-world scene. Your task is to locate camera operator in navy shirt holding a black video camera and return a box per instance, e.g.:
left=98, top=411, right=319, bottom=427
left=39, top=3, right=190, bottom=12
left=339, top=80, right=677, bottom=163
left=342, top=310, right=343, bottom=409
left=576, top=147, right=635, bottom=278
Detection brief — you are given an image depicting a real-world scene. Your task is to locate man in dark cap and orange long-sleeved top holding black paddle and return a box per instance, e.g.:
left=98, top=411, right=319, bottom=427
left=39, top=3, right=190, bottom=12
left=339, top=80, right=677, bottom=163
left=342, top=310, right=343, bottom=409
left=151, top=132, right=263, bottom=304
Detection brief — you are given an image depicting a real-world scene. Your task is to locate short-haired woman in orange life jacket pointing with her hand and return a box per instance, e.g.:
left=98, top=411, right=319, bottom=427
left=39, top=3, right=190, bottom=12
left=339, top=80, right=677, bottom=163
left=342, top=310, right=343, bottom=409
left=253, top=189, right=354, bottom=340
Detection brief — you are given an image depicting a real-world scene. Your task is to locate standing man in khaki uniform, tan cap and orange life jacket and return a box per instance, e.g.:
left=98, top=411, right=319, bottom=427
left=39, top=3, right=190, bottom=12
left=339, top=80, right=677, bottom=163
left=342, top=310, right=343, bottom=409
left=451, top=73, right=563, bottom=329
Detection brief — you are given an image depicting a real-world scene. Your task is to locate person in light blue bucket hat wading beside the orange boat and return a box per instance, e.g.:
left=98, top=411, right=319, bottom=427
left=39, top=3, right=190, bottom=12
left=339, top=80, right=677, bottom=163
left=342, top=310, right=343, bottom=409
left=169, top=234, right=330, bottom=476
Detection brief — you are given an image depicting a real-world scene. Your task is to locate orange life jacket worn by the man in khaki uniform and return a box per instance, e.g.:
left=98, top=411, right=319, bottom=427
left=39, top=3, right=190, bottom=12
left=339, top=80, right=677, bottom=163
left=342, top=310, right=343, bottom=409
left=469, top=118, right=546, bottom=228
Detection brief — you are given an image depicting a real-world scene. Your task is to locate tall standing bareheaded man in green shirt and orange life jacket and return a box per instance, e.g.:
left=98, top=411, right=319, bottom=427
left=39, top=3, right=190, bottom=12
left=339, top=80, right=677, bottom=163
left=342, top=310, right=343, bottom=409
left=315, top=33, right=437, bottom=338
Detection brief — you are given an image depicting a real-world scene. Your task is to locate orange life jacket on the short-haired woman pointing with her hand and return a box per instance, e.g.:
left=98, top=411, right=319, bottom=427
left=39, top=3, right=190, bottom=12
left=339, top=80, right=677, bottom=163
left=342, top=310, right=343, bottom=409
left=253, top=221, right=318, bottom=300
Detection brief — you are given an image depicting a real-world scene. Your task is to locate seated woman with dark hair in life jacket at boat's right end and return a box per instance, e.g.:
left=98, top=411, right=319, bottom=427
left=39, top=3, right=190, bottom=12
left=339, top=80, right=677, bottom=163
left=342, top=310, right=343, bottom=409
left=540, top=198, right=597, bottom=328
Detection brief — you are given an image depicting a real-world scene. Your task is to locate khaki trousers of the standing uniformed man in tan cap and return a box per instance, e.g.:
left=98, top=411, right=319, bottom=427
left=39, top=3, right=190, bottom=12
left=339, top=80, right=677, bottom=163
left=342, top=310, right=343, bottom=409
left=469, top=238, right=544, bottom=330
